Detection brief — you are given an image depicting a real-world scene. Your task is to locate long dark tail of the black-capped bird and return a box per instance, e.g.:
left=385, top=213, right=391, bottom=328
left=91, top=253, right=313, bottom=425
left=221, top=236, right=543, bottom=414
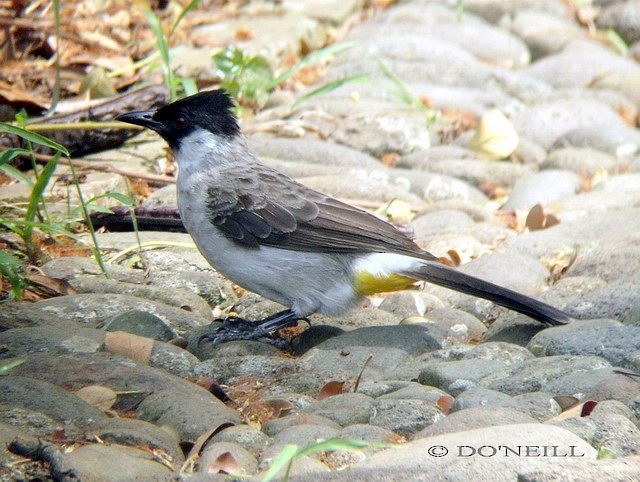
left=403, top=261, right=572, bottom=325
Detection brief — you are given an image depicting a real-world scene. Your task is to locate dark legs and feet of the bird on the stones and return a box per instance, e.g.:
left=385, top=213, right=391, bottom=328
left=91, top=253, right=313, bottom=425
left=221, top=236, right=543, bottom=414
left=198, top=310, right=301, bottom=344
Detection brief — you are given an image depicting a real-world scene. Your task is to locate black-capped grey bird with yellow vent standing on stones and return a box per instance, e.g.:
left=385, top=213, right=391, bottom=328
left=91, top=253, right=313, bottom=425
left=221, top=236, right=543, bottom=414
left=116, top=89, right=571, bottom=342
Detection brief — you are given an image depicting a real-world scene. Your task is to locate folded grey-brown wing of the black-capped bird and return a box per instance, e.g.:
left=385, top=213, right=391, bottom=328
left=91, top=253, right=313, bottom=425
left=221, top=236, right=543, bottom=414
left=207, top=165, right=436, bottom=260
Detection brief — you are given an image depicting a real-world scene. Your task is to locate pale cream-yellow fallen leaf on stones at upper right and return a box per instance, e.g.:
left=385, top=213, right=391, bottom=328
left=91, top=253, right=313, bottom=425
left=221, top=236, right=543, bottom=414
left=469, top=109, right=520, bottom=161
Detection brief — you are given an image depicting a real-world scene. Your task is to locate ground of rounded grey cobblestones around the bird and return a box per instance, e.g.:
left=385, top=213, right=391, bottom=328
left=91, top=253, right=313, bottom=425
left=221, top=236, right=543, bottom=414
left=0, top=0, right=640, bottom=481
